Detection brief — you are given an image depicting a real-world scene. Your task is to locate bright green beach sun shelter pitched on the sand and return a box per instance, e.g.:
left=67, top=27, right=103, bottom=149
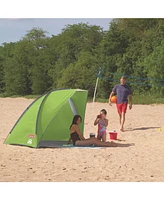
left=4, top=89, right=88, bottom=147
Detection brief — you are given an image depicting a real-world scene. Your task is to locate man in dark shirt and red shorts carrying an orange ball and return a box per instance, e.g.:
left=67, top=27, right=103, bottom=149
left=109, top=76, right=132, bottom=131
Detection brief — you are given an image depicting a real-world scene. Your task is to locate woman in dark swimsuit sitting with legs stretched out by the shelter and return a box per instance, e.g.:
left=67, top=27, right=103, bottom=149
left=70, top=115, right=117, bottom=147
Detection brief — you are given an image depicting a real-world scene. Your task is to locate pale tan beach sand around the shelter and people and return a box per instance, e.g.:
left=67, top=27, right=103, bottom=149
left=0, top=98, right=164, bottom=182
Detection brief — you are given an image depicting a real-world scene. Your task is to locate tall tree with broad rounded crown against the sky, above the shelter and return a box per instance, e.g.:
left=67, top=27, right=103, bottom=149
left=49, top=23, right=103, bottom=90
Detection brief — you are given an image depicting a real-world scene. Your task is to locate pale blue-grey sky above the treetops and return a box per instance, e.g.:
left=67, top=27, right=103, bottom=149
left=0, top=18, right=112, bottom=45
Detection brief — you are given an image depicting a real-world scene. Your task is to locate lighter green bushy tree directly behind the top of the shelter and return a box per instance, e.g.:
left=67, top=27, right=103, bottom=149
left=57, top=52, right=100, bottom=96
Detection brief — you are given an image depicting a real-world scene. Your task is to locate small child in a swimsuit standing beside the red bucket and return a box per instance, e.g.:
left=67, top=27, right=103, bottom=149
left=94, top=109, right=108, bottom=142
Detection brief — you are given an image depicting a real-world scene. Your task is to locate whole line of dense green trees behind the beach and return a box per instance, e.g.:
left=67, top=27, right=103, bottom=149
left=0, top=18, right=164, bottom=98
